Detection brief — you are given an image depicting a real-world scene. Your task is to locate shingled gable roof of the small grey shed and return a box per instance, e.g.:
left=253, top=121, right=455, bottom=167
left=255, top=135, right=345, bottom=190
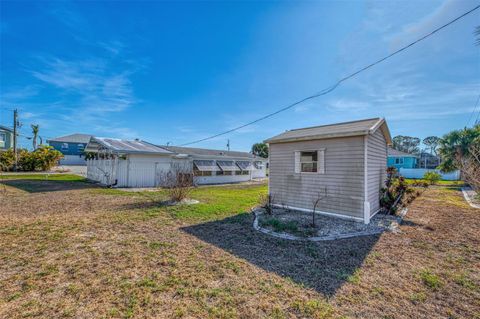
left=265, top=117, right=391, bottom=144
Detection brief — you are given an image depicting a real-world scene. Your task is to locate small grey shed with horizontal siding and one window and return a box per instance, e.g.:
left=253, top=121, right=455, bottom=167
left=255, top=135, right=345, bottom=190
left=265, top=118, right=392, bottom=223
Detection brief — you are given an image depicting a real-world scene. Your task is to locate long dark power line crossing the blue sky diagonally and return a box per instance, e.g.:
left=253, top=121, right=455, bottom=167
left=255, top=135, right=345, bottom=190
left=180, top=5, right=480, bottom=146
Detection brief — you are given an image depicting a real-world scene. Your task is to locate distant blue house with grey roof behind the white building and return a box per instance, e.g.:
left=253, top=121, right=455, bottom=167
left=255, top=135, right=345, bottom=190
left=47, top=133, right=92, bottom=165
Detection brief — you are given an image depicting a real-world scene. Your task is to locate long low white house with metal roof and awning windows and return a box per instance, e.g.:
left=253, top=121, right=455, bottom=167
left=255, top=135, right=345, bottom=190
left=85, top=137, right=266, bottom=187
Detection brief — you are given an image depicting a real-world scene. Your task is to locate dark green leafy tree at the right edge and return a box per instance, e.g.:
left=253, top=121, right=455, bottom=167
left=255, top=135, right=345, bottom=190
left=438, top=125, right=480, bottom=172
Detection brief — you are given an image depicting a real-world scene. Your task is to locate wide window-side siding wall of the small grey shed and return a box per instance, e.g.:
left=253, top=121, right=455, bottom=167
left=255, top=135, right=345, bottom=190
left=269, top=136, right=365, bottom=218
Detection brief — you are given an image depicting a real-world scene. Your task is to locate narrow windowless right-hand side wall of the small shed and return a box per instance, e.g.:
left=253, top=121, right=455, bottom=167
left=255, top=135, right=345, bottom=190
left=367, top=129, right=387, bottom=215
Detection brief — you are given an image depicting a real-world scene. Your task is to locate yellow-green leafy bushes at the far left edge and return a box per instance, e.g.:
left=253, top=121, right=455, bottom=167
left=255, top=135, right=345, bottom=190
left=0, top=145, right=63, bottom=172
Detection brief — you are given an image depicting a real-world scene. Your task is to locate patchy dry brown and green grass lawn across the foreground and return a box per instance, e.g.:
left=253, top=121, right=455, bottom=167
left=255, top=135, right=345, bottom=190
left=0, top=175, right=480, bottom=318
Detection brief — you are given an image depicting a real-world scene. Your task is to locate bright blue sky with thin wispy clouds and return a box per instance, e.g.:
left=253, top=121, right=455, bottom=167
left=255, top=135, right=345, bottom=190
left=0, top=0, right=480, bottom=150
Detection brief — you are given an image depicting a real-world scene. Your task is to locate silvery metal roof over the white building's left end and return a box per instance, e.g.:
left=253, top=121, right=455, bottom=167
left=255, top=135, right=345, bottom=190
left=85, top=137, right=172, bottom=154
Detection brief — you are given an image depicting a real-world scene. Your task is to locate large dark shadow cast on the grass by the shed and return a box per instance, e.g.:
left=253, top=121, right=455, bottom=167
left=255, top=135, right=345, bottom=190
left=182, top=213, right=379, bottom=296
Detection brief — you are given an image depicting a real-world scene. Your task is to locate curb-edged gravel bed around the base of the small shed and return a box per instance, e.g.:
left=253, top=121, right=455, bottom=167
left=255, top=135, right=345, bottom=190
left=258, top=209, right=404, bottom=238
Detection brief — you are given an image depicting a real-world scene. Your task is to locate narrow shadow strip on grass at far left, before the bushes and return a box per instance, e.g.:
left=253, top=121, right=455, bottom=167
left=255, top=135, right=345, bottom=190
left=0, top=179, right=99, bottom=193
